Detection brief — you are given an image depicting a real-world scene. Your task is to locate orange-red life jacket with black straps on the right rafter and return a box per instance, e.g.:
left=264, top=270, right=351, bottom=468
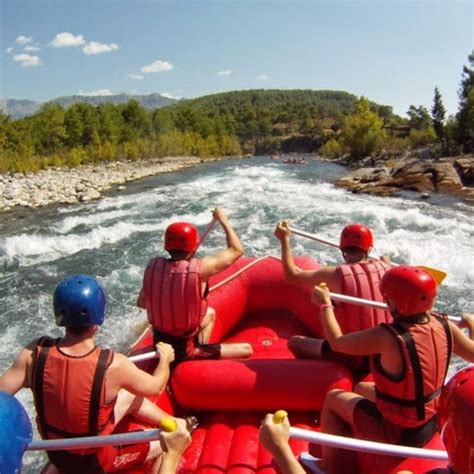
left=370, top=313, right=452, bottom=428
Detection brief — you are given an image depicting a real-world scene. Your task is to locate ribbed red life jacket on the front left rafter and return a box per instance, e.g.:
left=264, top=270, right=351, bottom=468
left=143, top=258, right=207, bottom=336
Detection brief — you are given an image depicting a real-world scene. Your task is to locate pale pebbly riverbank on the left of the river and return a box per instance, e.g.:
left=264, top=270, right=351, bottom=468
left=0, top=157, right=213, bottom=212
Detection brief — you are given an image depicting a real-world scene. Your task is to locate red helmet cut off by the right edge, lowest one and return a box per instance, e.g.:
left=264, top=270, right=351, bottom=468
left=438, top=366, right=474, bottom=473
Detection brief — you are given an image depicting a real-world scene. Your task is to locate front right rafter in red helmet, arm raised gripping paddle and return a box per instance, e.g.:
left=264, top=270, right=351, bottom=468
left=275, top=221, right=392, bottom=375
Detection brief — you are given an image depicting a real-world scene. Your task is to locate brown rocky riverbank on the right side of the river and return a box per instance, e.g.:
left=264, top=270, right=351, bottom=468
left=336, top=155, right=474, bottom=203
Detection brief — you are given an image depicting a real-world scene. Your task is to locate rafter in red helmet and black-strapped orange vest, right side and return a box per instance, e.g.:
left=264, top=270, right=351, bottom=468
left=312, top=265, right=474, bottom=474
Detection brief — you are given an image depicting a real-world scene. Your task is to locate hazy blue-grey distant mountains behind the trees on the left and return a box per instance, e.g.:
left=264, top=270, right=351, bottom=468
left=0, top=94, right=178, bottom=119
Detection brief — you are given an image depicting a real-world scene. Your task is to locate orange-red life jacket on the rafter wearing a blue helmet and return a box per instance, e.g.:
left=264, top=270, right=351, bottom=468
left=31, top=337, right=115, bottom=453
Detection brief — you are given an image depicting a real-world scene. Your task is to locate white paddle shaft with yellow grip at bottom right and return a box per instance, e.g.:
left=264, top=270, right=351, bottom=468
left=273, top=410, right=448, bottom=461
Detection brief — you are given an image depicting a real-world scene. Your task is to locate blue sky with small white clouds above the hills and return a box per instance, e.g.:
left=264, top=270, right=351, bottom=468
left=0, top=0, right=474, bottom=114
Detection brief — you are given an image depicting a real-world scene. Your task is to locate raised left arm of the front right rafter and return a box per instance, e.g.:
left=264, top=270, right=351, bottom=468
left=275, top=222, right=341, bottom=293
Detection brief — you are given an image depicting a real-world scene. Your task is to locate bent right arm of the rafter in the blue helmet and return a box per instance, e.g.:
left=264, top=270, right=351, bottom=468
left=109, top=343, right=174, bottom=397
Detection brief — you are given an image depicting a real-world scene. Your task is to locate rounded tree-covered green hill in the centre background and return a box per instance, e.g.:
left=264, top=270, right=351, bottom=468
left=154, top=90, right=400, bottom=153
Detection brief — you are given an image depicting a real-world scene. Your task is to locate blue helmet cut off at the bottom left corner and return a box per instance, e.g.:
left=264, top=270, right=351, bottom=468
left=0, top=391, right=33, bottom=474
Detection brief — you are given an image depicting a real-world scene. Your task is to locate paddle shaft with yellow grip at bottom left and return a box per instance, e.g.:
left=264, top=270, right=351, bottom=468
left=26, top=418, right=176, bottom=451
